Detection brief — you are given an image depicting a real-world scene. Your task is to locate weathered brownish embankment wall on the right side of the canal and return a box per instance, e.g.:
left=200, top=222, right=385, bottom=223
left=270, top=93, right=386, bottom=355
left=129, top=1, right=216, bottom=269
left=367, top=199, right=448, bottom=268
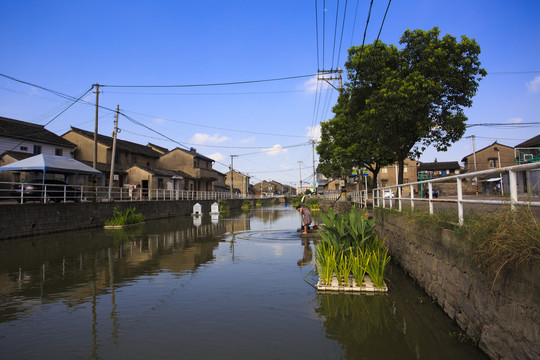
left=375, top=211, right=540, bottom=359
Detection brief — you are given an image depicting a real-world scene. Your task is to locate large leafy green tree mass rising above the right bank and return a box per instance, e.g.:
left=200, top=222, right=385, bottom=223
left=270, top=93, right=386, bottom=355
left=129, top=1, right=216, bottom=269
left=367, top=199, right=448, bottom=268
left=317, top=27, right=486, bottom=183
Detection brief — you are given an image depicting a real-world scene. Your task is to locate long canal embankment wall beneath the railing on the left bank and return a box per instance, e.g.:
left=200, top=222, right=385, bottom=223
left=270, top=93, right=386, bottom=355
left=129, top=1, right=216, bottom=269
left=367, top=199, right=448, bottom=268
left=0, top=199, right=264, bottom=240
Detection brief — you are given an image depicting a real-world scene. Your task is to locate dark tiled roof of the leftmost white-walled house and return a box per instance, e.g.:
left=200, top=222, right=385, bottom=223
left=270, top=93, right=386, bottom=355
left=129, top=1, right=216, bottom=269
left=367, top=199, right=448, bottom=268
left=0, top=117, right=76, bottom=148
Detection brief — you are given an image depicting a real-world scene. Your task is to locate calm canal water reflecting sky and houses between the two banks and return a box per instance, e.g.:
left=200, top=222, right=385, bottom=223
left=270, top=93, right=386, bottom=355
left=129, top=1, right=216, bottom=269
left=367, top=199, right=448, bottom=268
left=0, top=207, right=486, bottom=360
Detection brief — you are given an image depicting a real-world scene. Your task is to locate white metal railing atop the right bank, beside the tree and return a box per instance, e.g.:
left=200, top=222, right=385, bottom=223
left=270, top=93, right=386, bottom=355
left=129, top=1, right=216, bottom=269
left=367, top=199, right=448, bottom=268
left=372, top=163, right=540, bottom=225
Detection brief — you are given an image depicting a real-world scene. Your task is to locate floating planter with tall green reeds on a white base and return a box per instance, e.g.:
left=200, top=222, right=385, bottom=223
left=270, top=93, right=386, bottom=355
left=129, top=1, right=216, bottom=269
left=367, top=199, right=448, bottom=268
left=313, top=209, right=390, bottom=292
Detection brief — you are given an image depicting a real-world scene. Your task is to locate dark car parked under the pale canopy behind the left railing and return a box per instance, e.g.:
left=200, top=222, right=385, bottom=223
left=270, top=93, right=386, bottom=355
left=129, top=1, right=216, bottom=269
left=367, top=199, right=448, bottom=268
left=11, top=179, right=81, bottom=202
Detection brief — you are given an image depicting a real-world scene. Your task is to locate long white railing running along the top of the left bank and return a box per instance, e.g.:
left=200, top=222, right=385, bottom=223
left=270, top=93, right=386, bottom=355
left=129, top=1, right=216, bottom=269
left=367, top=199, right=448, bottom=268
left=0, top=182, right=255, bottom=203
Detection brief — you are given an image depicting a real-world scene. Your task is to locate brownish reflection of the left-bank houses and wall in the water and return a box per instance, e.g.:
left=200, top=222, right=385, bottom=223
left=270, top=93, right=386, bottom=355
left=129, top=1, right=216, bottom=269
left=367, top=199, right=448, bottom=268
left=0, top=217, right=230, bottom=322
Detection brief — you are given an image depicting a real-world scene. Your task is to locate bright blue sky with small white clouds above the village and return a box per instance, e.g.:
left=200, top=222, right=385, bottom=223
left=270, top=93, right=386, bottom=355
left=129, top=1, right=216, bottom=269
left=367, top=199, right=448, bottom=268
left=0, top=0, right=540, bottom=185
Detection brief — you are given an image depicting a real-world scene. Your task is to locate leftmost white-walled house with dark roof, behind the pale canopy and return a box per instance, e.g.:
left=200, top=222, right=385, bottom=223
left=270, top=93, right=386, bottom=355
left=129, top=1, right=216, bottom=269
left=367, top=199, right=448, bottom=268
left=0, top=117, right=76, bottom=182
